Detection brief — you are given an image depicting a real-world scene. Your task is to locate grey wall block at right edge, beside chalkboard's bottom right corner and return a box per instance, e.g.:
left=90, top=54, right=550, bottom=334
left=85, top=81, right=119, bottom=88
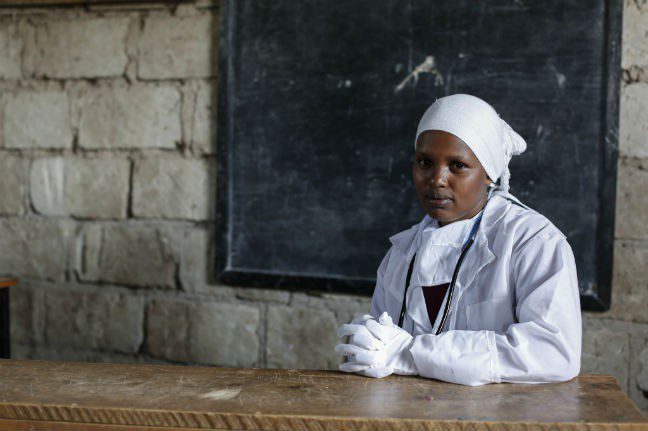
left=609, top=240, right=648, bottom=323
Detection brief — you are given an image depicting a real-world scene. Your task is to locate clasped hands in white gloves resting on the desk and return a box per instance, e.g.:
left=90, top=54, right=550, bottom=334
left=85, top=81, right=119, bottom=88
left=335, top=312, right=418, bottom=378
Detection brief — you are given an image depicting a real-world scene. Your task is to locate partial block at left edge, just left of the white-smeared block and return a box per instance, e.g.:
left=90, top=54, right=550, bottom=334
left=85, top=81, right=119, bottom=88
left=0, top=152, right=29, bottom=215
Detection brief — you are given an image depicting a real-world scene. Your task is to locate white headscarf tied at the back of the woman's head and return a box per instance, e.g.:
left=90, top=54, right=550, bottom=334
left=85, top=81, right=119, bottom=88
left=414, top=94, right=526, bottom=202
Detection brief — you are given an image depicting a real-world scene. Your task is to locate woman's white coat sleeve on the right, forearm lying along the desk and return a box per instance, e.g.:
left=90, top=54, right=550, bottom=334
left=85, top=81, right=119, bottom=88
left=410, top=233, right=582, bottom=386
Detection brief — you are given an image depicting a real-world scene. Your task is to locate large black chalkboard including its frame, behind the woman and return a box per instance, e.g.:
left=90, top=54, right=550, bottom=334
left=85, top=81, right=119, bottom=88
left=216, top=0, right=622, bottom=310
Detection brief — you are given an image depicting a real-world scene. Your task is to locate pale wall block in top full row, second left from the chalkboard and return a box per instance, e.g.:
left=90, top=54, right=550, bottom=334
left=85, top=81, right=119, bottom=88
left=25, top=17, right=130, bottom=79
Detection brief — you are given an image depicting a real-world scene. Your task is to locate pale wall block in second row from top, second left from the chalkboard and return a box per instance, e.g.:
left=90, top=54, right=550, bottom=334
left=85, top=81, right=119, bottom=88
left=77, top=86, right=181, bottom=149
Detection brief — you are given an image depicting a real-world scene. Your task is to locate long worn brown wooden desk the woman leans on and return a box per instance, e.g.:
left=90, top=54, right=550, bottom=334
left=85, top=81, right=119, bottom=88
left=0, top=359, right=648, bottom=431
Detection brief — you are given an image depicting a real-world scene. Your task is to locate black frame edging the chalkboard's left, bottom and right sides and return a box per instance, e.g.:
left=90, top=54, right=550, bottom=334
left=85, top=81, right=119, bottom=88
left=214, top=0, right=623, bottom=311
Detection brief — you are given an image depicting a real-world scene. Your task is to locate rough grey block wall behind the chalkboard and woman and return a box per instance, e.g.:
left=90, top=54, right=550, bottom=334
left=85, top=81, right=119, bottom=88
left=0, top=0, right=648, bottom=412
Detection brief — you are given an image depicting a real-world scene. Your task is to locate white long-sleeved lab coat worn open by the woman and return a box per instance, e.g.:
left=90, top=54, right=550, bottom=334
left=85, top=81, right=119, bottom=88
left=371, top=195, right=582, bottom=386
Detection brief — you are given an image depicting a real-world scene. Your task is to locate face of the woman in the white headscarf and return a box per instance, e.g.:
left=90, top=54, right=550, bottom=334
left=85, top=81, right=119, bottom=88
left=412, top=130, right=491, bottom=226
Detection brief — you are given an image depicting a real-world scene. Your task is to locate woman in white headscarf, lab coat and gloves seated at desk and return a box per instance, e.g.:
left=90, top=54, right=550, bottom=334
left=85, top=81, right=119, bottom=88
left=336, top=94, right=581, bottom=385
